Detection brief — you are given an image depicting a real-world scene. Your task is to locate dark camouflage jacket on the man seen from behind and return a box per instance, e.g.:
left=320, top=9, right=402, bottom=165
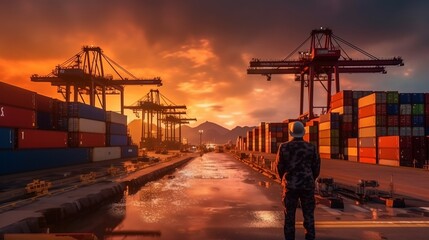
left=276, top=138, right=320, bottom=189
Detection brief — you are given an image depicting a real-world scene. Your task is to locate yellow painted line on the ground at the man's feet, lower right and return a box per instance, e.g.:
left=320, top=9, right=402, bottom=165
left=296, top=221, right=429, bottom=228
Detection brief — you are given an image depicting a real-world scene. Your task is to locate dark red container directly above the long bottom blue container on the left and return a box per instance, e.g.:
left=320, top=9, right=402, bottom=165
left=18, top=129, right=67, bottom=148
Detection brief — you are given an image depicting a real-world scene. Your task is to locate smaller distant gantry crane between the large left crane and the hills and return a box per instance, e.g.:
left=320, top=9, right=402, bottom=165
left=125, top=90, right=196, bottom=149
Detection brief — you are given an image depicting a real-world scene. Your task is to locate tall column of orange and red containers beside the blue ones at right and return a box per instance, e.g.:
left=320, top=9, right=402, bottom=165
left=358, top=92, right=387, bottom=164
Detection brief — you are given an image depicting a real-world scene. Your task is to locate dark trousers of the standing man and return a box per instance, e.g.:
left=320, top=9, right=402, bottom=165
left=283, top=189, right=316, bottom=240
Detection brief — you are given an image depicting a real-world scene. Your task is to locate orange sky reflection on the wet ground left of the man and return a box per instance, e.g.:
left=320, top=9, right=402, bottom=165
left=110, top=154, right=283, bottom=237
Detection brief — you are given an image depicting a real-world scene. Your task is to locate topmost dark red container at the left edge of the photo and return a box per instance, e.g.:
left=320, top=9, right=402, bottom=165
left=0, top=82, right=36, bottom=110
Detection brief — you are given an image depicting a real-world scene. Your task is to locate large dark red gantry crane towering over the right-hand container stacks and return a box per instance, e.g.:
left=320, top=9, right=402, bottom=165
left=247, top=28, right=404, bottom=119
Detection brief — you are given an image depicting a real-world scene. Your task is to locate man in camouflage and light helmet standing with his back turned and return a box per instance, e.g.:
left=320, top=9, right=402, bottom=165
left=275, top=121, right=320, bottom=240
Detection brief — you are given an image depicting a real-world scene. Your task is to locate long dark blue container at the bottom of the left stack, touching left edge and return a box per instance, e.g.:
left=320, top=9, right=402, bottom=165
left=0, top=148, right=91, bottom=175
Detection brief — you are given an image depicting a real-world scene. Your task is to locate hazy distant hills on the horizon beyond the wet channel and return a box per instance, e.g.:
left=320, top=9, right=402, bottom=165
left=128, top=119, right=254, bottom=145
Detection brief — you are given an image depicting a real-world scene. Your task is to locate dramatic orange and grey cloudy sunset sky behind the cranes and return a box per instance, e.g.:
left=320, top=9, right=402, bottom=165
left=0, top=0, right=429, bottom=128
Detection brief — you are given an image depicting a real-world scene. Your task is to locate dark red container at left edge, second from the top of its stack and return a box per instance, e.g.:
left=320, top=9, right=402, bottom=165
left=0, top=105, right=36, bottom=128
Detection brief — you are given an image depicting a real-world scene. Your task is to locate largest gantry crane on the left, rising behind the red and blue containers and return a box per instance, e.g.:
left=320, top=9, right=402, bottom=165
left=31, top=46, right=162, bottom=114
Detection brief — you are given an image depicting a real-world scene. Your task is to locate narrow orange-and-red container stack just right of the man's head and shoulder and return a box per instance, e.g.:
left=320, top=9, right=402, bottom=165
left=319, top=113, right=340, bottom=159
